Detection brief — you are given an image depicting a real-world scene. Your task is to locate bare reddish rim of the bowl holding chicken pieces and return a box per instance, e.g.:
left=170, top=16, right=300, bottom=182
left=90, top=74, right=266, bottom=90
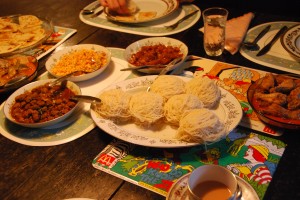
left=247, top=77, right=300, bottom=129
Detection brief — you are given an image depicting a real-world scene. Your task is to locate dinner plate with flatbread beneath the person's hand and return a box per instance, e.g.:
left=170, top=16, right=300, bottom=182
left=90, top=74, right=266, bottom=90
left=104, top=0, right=179, bottom=24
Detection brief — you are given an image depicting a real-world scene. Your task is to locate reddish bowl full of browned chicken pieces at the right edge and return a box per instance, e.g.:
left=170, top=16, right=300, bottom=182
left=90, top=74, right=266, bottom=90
left=247, top=73, right=300, bottom=129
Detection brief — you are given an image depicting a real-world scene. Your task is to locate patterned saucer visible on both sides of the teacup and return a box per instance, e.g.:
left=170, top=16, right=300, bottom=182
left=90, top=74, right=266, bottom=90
left=166, top=173, right=259, bottom=200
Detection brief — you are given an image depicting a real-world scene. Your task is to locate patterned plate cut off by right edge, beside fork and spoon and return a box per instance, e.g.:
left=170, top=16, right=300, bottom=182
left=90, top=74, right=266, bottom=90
left=280, top=24, right=300, bottom=58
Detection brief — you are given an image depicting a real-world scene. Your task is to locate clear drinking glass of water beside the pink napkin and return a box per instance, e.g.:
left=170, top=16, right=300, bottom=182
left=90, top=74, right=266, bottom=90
left=203, top=7, right=228, bottom=56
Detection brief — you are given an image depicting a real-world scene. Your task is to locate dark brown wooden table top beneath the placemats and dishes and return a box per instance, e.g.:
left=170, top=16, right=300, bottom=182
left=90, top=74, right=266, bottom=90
left=0, top=0, right=300, bottom=199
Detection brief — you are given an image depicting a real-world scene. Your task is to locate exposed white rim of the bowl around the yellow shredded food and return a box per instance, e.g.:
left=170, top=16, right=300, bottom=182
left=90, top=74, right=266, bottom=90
left=45, top=44, right=111, bottom=82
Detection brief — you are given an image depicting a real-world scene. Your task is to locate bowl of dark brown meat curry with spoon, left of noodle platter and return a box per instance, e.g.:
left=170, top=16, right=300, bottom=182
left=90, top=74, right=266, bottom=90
left=4, top=79, right=81, bottom=128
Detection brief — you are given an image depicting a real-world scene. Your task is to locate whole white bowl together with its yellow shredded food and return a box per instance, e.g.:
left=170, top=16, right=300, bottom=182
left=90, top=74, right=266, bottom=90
left=45, top=44, right=111, bottom=82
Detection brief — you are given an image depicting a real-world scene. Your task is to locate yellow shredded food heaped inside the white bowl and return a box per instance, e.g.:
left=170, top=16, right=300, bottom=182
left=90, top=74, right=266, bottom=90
left=51, top=49, right=107, bottom=76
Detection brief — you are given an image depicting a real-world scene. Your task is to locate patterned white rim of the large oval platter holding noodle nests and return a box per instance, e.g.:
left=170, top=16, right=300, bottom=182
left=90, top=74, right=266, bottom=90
left=90, top=75, right=243, bottom=148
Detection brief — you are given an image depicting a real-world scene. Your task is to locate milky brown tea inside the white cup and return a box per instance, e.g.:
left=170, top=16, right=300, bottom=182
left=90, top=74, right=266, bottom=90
left=193, top=181, right=232, bottom=200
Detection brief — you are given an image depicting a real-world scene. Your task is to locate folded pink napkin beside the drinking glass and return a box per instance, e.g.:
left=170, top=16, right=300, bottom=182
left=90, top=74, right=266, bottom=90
left=199, top=12, right=254, bottom=55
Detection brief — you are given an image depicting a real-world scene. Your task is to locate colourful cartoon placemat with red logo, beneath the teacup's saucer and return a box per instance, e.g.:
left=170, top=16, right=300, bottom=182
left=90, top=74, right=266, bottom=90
left=92, top=128, right=286, bottom=199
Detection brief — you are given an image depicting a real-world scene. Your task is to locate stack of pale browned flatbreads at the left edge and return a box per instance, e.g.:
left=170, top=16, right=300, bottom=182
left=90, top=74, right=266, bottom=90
left=0, top=15, right=45, bottom=54
